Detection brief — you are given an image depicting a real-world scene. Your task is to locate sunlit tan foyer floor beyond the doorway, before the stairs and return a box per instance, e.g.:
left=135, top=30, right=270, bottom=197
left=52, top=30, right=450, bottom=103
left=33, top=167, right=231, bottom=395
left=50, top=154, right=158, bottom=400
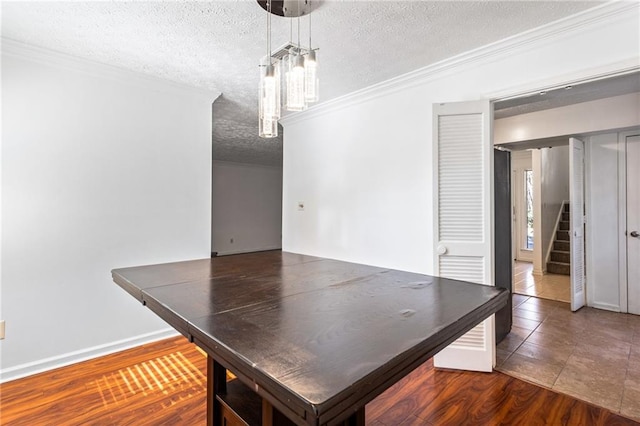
left=513, top=262, right=571, bottom=303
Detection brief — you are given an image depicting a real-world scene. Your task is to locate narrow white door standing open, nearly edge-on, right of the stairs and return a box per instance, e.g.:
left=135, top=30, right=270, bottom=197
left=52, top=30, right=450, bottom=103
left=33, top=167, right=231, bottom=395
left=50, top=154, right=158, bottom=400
left=569, top=138, right=586, bottom=311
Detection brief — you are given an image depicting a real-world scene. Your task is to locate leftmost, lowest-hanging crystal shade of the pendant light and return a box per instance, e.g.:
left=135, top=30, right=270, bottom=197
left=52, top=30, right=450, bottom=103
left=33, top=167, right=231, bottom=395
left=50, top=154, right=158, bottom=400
left=258, top=64, right=280, bottom=138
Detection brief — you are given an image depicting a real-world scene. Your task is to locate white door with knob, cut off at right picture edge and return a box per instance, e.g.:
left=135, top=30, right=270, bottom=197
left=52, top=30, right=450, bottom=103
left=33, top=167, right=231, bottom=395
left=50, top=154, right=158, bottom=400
left=626, top=136, right=640, bottom=315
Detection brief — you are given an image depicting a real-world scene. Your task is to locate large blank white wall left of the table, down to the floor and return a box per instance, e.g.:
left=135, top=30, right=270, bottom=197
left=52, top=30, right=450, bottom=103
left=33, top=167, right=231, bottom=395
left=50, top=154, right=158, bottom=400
left=0, top=40, right=215, bottom=380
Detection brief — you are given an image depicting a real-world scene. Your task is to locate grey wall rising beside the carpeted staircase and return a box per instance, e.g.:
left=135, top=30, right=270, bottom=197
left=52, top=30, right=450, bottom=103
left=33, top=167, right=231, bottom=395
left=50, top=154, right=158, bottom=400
left=539, top=145, right=569, bottom=269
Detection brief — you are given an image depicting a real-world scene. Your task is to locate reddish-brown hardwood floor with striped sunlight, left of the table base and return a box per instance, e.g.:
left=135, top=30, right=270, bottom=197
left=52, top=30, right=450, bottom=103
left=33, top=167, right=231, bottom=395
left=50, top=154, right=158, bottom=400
left=0, top=337, right=206, bottom=426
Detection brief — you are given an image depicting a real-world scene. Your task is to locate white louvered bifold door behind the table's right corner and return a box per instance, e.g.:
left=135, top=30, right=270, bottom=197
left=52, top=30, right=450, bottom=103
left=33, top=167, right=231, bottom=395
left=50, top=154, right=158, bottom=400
left=433, top=101, right=495, bottom=371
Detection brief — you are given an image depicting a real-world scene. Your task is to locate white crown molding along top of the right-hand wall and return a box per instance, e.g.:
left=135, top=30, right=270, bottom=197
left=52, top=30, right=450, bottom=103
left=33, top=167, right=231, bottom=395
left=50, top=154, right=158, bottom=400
left=280, top=1, right=640, bottom=126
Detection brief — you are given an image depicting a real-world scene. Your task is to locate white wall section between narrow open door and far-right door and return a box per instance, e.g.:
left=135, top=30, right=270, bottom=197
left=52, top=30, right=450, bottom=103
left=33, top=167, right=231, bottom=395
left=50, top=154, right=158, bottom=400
left=585, top=133, right=626, bottom=311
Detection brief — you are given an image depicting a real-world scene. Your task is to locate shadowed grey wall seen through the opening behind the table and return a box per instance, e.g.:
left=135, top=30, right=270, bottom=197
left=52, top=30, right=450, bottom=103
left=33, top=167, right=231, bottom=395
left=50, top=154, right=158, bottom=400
left=212, top=161, right=282, bottom=255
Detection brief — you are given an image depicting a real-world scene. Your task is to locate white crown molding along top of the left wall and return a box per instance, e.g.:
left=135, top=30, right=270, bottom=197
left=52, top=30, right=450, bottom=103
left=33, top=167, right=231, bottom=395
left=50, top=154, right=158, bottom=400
left=0, top=37, right=221, bottom=102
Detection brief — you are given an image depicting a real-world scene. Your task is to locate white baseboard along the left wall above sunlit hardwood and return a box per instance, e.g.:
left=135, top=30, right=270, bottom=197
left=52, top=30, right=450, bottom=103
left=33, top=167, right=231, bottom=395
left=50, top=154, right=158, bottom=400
left=0, top=328, right=179, bottom=383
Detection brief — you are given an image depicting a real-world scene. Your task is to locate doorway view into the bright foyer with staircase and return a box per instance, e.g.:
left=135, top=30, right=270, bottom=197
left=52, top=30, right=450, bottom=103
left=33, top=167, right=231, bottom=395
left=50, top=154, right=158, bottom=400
left=511, top=145, right=571, bottom=302
